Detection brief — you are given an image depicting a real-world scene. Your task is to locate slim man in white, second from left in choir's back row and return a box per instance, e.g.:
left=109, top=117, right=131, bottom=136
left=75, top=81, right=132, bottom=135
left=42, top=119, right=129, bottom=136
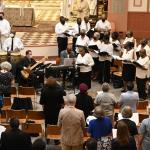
left=72, top=18, right=82, bottom=53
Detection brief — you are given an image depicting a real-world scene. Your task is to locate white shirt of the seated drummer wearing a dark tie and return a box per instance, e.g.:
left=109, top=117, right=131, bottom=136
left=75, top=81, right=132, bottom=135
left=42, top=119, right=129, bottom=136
left=3, top=37, right=24, bottom=51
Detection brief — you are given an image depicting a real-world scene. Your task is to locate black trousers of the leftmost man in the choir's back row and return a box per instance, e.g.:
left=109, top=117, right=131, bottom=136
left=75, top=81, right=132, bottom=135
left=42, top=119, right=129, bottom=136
left=57, top=37, right=68, bottom=56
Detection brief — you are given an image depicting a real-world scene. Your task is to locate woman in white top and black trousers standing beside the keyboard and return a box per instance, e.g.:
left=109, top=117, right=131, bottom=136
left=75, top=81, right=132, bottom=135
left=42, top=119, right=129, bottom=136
left=76, top=46, right=94, bottom=89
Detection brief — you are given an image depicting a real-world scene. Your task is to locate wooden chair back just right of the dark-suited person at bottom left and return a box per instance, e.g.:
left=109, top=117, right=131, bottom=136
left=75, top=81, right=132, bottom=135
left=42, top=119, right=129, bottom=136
left=21, top=123, right=44, bottom=135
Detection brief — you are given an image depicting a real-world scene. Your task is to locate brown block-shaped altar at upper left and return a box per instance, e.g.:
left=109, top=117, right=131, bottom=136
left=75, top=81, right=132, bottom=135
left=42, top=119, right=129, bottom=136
left=4, top=7, right=35, bottom=26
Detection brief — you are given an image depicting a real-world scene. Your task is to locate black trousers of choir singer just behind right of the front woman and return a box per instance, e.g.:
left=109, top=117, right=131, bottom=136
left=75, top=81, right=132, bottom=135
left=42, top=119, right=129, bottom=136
left=99, top=60, right=111, bottom=83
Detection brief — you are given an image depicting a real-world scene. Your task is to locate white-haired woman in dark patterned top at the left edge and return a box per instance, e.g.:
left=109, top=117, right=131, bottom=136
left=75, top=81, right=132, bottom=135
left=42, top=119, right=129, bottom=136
left=0, top=61, right=14, bottom=97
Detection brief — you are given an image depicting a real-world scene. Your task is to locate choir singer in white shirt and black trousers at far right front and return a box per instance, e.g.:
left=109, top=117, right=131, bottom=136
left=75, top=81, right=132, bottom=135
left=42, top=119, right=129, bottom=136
left=136, top=49, right=150, bottom=99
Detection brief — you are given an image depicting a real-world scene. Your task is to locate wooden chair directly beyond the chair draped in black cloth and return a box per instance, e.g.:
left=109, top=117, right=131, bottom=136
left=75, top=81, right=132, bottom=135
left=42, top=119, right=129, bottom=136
left=18, top=86, right=36, bottom=108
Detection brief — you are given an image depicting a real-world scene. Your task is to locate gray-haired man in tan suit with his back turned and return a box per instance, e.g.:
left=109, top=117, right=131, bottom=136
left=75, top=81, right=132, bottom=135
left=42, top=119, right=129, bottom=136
left=58, top=94, right=85, bottom=150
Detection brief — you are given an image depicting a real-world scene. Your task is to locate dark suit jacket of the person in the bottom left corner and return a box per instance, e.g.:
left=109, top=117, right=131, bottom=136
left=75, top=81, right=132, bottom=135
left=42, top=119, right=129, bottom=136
left=1, top=129, right=32, bottom=150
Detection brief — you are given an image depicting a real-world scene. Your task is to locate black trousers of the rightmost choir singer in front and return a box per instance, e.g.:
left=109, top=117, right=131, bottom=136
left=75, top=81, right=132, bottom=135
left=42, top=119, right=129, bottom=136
left=136, top=77, right=147, bottom=99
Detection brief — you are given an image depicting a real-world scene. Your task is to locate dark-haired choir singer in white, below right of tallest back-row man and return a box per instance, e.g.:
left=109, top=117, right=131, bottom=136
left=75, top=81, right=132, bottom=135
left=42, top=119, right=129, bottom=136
left=110, top=32, right=121, bottom=56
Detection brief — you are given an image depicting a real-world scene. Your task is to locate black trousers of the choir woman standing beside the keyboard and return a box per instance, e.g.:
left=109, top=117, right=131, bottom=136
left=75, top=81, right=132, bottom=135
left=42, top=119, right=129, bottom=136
left=79, top=71, right=91, bottom=89
